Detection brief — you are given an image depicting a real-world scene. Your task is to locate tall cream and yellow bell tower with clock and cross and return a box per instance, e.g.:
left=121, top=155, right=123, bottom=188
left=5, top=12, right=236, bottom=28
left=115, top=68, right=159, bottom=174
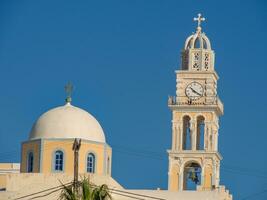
left=168, top=14, right=223, bottom=191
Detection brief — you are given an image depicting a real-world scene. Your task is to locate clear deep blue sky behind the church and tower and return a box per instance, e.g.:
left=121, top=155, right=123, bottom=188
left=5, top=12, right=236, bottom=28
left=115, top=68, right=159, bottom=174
left=0, top=0, right=267, bottom=200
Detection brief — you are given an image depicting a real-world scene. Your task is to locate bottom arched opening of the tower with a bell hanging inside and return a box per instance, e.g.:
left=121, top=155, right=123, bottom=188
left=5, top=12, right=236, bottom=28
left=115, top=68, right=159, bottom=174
left=183, top=162, right=201, bottom=190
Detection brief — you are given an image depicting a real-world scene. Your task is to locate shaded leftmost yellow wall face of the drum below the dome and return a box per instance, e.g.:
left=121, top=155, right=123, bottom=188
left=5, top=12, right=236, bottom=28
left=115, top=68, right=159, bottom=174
left=20, top=140, right=41, bottom=173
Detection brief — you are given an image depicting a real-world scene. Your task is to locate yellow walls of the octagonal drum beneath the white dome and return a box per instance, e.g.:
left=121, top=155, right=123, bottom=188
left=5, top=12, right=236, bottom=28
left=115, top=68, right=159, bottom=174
left=21, top=139, right=112, bottom=174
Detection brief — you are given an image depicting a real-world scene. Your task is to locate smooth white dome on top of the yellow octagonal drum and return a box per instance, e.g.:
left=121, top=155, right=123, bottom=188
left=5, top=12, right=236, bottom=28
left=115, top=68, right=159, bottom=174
left=29, top=103, right=105, bottom=143
